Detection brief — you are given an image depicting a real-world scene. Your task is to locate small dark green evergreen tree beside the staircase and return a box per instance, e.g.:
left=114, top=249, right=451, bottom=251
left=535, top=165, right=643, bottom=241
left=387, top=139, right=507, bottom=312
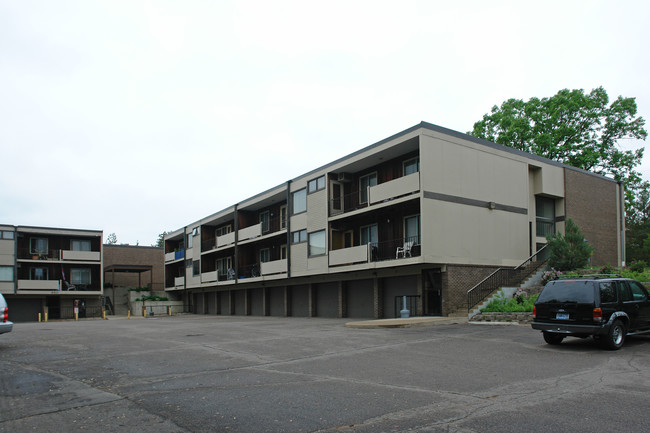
left=548, top=218, right=594, bottom=272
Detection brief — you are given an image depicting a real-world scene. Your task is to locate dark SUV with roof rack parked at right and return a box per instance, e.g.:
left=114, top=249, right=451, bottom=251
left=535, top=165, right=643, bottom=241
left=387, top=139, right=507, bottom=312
left=532, top=275, right=650, bottom=350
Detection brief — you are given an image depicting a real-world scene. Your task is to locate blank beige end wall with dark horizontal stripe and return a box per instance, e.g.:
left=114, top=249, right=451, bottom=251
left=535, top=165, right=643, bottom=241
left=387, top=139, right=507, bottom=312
left=420, top=131, right=530, bottom=266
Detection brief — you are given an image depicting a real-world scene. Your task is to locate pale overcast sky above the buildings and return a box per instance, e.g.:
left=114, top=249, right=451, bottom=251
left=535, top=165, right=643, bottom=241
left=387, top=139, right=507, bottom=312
left=0, top=0, right=650, bottom=245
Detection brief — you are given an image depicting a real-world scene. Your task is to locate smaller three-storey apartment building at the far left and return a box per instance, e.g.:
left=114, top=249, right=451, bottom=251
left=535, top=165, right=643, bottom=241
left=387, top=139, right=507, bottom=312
left=0, top=225, right=103, bottom=322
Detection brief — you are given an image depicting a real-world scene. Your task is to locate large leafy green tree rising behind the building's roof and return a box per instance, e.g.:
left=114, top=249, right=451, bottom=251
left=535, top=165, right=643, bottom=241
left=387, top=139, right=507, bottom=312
left=469, top=87, right=648, bottom=190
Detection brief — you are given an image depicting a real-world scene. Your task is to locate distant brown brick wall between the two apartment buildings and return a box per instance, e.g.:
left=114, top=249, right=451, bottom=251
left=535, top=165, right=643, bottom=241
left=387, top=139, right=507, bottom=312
left=104, top=245, right=165, bottom=290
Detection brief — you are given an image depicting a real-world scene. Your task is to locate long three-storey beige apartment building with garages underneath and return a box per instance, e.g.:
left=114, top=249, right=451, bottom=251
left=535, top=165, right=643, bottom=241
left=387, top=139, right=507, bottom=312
left=165, top=122, right=624, bottom=318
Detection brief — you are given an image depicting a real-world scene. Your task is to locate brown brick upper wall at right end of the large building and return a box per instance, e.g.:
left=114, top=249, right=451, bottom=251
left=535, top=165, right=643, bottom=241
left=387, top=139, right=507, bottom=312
left=564, top=169, right=619, bottom=266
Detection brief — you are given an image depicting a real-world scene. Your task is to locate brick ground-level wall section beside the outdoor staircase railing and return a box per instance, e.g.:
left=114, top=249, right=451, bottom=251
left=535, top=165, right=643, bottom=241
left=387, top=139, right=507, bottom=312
left=442, top=265, right=498, bottom=316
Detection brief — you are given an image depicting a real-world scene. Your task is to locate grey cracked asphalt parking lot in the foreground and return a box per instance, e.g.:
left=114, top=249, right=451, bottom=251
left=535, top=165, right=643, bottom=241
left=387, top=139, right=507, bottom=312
left=0, top=315, right=650, bottom=433
